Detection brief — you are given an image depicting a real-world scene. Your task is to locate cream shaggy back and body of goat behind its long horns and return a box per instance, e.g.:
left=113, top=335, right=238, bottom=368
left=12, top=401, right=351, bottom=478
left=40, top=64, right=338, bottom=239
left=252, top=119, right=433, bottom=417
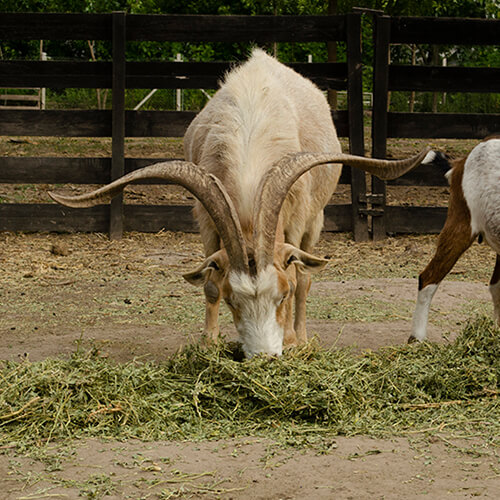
left=184, top=49, right=340, bottom=238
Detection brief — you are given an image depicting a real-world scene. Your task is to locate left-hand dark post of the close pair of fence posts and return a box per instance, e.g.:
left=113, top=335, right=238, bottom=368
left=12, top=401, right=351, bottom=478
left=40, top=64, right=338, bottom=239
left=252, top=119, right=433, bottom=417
left=346, top=14, right=369, bottom=241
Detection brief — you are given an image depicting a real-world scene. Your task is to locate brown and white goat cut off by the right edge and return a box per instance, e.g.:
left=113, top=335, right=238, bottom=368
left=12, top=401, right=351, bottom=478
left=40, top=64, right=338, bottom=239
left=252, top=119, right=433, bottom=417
left=408, top=137, right=500, bottom=342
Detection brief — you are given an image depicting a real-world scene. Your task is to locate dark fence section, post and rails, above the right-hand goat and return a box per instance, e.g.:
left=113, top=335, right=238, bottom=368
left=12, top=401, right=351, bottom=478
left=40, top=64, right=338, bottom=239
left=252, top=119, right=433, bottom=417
left=372, top=16, right=500, bottom=239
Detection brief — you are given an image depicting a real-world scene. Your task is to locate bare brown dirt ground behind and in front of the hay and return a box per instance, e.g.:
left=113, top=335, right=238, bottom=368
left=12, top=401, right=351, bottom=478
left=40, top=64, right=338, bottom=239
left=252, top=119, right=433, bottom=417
left=0, top=232, right=500, bottom=499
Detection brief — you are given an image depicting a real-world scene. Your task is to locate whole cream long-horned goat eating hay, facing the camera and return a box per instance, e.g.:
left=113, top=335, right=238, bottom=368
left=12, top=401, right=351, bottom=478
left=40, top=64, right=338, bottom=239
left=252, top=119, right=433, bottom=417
left=48, top=49, right=425, bottom=357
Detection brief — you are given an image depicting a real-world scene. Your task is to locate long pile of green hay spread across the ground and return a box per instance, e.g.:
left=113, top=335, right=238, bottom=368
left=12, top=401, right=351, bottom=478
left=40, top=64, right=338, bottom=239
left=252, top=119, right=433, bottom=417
left=0, top=318, right=500, bottom=446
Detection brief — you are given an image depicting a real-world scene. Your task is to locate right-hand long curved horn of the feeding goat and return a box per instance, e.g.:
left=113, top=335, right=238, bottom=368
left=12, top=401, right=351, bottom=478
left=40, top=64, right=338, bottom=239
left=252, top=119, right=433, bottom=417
left=253, top=148, right=429, bottom=270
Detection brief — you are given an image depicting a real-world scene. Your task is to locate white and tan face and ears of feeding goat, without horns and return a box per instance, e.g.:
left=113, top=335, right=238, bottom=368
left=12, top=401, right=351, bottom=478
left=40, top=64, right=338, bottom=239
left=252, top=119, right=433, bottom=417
left=184, top=244, right=327, bottom=357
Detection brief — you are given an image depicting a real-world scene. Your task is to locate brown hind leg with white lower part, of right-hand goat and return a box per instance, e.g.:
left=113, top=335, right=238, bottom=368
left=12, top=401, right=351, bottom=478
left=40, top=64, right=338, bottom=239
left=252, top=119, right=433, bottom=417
left=408, top=223, right=474, bottom=342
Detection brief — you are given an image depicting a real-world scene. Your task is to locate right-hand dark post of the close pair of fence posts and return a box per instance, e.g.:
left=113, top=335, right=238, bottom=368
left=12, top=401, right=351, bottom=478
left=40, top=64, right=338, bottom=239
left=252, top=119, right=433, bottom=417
left=371, top=16, right=391, bottom=240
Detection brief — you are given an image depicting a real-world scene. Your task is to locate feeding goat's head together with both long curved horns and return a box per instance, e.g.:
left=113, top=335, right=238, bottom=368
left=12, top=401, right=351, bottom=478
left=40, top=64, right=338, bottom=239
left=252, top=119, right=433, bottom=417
left=50, top=151, right=427, bottom=356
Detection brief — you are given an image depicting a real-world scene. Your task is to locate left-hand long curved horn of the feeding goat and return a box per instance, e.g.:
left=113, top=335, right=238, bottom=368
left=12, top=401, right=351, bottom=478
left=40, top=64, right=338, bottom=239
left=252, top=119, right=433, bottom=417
left=49, top=160, right=249, bottom=272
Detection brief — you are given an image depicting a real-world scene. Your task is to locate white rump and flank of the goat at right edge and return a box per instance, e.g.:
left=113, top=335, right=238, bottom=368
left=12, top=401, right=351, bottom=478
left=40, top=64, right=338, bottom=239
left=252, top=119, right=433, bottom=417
left=462, top=139, right=500, bottom=253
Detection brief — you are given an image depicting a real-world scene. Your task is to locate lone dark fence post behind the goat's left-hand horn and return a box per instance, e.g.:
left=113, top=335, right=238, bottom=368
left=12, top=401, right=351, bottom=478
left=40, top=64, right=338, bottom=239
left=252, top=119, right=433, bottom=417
left=109, top=12, right=126, bottom=240
